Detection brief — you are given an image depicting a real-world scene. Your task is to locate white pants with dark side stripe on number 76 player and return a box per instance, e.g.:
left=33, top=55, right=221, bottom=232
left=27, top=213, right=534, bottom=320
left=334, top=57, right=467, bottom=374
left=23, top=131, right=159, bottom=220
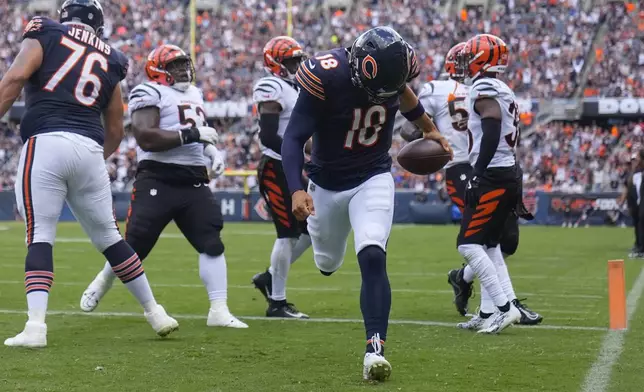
left=16, top=132, right=121, bottom=252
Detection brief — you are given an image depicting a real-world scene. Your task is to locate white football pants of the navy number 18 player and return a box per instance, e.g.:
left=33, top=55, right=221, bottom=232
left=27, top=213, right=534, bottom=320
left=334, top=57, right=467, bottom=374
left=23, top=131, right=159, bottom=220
left=308, top=173, right=394, bottom=272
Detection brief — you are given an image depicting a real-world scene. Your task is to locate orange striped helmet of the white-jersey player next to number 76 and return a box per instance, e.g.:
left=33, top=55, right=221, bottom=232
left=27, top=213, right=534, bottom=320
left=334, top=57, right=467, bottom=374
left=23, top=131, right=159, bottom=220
left=145, top=44, right=195, bottom=91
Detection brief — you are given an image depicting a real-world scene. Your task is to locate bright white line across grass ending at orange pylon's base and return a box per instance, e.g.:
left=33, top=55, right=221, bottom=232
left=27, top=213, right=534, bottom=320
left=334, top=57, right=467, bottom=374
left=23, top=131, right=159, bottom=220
left=0, top=309, right=606, bottom=331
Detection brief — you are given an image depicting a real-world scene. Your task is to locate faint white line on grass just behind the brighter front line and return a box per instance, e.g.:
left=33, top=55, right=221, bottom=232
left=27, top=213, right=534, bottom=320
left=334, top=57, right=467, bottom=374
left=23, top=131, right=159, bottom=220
left=0, top=280, right=604, bottom=299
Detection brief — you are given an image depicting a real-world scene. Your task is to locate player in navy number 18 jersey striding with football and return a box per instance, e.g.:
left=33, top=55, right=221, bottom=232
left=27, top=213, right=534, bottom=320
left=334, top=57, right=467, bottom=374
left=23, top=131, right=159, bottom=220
left=282, top=27, right=451, bottom=381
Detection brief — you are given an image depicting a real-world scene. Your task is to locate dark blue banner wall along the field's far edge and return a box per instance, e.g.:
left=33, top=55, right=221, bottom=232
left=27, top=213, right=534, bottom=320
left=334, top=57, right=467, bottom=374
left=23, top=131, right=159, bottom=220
left=0, top=190, right=631, bottom=226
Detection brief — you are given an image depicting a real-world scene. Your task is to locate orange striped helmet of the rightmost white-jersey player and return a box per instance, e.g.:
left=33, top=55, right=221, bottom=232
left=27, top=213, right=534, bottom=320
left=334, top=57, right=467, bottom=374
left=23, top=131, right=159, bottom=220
left=459, top=34, right=510, bottom=79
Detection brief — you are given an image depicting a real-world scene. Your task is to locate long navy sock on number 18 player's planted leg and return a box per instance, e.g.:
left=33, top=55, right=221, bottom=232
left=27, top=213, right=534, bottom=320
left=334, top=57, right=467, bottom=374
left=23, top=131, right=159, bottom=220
left=358, top=245, right=391, bottom=352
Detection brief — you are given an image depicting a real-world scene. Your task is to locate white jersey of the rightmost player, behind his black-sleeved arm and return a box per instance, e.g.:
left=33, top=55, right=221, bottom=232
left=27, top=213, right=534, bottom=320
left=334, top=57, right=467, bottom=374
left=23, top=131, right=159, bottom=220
left=467, top=78, right=519, bottom=167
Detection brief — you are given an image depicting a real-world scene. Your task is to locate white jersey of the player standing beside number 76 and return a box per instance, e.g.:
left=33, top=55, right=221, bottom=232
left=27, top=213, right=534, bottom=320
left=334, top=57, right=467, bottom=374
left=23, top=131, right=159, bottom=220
left=128, top=82, right=207, bottom=166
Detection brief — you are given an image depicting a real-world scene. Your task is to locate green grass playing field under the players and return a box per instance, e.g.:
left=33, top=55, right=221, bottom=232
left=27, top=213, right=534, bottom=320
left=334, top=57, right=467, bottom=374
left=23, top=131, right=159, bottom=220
left=0, top=223, right=644, bottom=392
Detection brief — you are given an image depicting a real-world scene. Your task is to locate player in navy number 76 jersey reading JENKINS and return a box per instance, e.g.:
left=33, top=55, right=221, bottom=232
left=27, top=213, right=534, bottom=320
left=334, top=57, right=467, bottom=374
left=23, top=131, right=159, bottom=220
left=0, top=0, right=179, bottom=347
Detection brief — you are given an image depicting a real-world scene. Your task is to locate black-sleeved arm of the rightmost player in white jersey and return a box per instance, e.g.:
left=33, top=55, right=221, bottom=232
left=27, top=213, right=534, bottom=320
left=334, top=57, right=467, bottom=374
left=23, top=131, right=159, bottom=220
left=474, top=98, right=501, bottom=177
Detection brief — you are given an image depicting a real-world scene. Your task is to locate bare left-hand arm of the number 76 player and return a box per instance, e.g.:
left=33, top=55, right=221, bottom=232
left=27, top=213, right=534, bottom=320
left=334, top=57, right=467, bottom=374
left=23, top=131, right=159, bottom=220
left=0, top=38, right=43, bottom=118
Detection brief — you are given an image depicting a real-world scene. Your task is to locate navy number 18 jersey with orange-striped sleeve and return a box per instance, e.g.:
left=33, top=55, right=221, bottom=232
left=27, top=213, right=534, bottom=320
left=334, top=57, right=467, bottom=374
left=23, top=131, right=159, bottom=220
left=294, top=48, right=399, bottom=191
